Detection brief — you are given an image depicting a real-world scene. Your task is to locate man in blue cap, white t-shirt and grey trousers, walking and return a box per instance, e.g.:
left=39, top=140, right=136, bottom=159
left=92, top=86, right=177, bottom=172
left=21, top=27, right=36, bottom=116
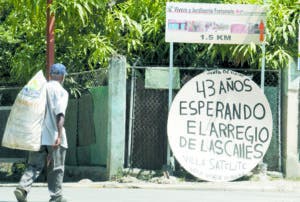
left=14, top=63, right=69, bottom=202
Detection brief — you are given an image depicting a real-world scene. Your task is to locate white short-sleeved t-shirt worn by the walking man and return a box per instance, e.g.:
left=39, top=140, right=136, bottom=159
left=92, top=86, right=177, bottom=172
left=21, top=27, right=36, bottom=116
left=42, top=80, right=69, bottom=148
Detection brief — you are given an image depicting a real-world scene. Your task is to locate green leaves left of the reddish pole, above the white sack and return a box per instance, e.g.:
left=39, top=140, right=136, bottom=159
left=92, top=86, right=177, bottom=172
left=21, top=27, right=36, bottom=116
left=0, top=0, right=46, bottom=82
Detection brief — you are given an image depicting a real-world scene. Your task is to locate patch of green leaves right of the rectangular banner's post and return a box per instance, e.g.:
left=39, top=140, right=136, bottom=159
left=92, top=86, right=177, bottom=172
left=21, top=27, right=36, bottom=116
left=267, top=0, right=300, bottom=69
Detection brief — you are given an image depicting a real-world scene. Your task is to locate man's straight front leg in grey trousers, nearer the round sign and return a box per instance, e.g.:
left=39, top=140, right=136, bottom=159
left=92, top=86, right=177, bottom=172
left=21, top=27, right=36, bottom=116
left=47, top=146, right=66, bottom=201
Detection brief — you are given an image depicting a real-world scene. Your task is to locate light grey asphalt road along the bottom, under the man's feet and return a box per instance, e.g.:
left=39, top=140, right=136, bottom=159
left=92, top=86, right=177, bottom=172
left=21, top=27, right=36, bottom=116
left=0, top=187, right=300, bottom=202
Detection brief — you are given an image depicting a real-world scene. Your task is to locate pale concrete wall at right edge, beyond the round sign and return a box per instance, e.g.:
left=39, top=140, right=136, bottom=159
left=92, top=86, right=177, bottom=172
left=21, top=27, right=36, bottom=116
left=282, top=58, right=300, bottom=178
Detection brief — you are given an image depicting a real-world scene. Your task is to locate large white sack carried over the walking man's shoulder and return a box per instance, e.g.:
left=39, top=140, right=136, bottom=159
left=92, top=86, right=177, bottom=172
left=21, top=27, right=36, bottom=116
left=2, top=70, right=47, bottom=151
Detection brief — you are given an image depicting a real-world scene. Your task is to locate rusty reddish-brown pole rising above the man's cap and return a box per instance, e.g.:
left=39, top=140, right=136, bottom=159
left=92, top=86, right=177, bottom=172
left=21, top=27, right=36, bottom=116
left=46, top=0, right=55, bottom=80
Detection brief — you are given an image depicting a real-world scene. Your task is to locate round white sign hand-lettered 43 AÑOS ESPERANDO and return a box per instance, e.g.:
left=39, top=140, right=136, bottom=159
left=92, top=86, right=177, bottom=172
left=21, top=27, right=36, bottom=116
left=168, top=69, right=272, bottom=181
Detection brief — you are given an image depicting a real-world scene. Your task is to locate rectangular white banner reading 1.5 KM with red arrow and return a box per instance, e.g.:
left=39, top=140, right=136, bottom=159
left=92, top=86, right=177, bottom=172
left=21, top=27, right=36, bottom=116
left=165, top=2, right=266, bottom=44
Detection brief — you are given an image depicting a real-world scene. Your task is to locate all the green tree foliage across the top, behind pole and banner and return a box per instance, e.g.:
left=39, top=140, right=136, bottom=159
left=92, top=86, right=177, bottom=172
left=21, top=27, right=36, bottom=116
left=0, top=0, right=299, bottom=83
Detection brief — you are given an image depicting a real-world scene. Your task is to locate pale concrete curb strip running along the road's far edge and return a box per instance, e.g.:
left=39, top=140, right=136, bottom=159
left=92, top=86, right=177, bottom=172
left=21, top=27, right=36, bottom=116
left=0, top=180, right=300, bottom=193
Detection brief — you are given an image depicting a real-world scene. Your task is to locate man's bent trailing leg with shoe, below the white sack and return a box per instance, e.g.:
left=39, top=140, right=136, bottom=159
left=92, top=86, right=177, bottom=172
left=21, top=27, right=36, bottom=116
left=14, top=146, right=47, bottom=202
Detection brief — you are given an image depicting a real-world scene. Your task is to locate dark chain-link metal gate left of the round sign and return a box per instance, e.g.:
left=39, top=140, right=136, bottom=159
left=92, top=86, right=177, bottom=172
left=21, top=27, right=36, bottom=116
left=128, top=69, right=168, bottom=170
